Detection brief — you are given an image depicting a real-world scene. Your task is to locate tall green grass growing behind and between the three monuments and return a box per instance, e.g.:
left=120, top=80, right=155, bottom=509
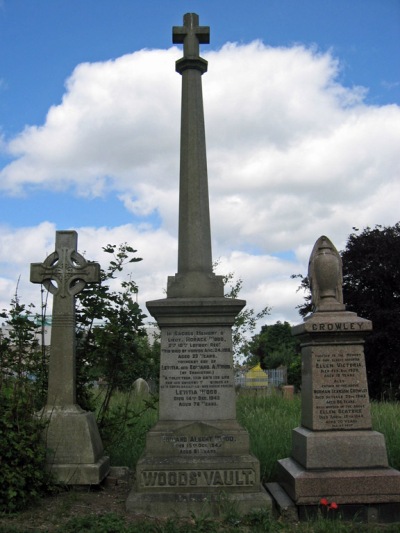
left=105, top=386, right=400, bottom=481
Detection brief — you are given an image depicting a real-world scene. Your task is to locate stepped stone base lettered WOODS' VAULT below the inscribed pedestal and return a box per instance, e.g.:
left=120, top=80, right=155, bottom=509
left=126, top=420, right=272, bottom=517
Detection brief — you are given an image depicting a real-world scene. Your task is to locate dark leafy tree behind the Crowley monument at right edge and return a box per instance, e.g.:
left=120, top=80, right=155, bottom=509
left=295, top=222, right=400, bottom=400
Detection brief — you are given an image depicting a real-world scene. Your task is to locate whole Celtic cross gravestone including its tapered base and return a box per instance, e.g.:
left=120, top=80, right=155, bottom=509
left=31, top=231, right=109, bottom=485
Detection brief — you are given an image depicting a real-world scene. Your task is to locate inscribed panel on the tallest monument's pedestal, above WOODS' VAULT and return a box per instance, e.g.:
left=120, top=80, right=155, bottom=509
left=160, top=326, right=236, bottom=420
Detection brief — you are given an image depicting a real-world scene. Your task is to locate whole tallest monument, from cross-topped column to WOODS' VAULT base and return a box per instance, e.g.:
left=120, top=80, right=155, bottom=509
left=127, top=13, right=271, bottom=516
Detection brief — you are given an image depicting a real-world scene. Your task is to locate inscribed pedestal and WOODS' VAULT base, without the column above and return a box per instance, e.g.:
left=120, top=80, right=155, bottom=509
left=127, top=298, right=271, bottom=516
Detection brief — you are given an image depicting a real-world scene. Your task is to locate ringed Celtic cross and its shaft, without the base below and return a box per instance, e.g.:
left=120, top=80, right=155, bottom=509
left=31, top=231, right=100, bottom=406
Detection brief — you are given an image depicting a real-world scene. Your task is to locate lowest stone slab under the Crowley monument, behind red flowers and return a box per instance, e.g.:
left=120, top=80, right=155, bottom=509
left=277, top=451, right=400, bottom=506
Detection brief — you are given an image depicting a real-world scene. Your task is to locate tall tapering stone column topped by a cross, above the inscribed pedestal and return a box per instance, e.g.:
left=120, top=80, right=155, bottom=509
left=167, top=13, right=223, bottom=298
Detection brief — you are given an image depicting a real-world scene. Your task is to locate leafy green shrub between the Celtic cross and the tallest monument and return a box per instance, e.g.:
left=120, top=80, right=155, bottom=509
left=77, top=243, right=159, bottom=429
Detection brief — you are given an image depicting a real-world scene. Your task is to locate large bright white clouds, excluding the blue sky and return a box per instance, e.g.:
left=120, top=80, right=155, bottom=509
left=0, top=42, right=400, bottom=328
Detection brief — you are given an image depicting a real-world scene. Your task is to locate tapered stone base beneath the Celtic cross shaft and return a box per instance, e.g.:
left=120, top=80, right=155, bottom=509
left=40, top=405, right=110, bottom=485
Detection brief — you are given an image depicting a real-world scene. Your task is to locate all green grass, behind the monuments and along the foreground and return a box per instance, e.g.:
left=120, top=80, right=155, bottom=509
left=0, top=388, right=400, bottom=533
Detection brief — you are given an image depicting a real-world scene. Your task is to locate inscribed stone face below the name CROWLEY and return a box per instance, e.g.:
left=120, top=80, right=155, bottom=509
left=302, top=345, right=371, bottom=430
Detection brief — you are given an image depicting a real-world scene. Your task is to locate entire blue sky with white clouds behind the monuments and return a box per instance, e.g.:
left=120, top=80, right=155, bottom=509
left=0, top=0, right=400, bottom=327
